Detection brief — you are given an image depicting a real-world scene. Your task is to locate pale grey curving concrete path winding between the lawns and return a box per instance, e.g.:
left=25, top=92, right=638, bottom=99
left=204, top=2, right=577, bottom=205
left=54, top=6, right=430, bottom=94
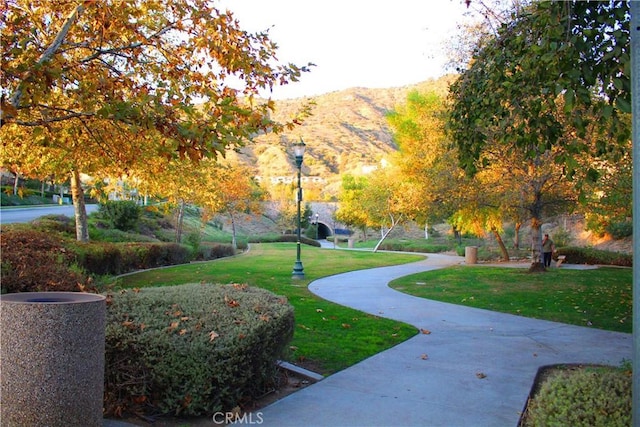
left=254, top=254, right=632, bottom=427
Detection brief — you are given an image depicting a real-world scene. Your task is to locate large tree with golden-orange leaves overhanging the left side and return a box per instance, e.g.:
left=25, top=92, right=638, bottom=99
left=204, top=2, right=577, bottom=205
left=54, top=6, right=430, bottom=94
left=0, top=0, right=308, bottom=240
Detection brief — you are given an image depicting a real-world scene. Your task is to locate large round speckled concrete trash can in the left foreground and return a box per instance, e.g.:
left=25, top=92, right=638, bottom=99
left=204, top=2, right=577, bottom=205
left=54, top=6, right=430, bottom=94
left=0, top=292, right=107, bottom=427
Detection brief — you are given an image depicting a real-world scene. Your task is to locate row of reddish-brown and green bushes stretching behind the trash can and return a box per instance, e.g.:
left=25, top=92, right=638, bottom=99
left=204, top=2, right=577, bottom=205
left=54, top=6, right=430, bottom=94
left=0, top=231, right=234, bottom=293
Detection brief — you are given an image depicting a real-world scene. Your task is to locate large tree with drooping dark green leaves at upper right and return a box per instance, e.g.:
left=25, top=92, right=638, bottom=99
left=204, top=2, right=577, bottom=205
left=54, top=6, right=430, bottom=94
left=448, top=1, right=631, bottom=268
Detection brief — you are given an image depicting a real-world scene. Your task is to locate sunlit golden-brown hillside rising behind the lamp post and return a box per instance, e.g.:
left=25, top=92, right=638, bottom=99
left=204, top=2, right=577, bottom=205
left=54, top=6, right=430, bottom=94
left=230, top=78, right=456, bottom=196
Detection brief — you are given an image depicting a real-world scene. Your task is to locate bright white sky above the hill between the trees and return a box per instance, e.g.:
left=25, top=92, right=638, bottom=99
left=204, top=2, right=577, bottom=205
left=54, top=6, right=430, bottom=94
left=218, top=0, right=466, bottom=99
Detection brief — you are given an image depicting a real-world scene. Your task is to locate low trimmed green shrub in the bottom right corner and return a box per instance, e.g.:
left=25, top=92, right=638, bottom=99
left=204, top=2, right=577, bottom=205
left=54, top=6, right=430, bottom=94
left=524, top=367, right=631, bottom=426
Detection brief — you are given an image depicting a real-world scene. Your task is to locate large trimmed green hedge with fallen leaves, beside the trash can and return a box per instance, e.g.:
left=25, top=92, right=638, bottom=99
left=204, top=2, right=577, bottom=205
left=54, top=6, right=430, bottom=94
left=105, top=284, right=294, bottom=415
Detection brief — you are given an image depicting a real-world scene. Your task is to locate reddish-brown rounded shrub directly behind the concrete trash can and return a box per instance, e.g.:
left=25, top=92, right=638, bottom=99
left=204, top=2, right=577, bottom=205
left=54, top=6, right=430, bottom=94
left=0, top=229, right=90, bottom=293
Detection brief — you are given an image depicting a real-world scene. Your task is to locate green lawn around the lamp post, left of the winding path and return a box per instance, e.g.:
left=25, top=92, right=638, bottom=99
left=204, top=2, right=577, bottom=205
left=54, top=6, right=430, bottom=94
left=115, top=243, right=423, bottom=374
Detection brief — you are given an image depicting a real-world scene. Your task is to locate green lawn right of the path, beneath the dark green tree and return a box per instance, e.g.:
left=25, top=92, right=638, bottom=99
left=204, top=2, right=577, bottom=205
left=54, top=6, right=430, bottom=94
left=391, top=266, right=633, bottom=333
